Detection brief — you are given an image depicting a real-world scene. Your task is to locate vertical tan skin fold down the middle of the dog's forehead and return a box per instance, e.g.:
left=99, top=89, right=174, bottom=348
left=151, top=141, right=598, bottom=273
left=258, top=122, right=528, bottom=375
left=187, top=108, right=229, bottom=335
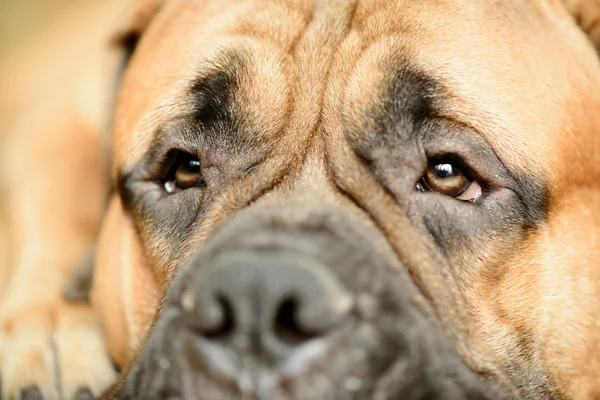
left=268, top=0, right=358, bottom=202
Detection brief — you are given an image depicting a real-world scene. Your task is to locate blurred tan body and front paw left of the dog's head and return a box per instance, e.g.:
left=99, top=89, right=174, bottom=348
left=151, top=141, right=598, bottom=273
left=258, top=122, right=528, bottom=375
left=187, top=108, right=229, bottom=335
left=0, top=1, right=129, bottom=399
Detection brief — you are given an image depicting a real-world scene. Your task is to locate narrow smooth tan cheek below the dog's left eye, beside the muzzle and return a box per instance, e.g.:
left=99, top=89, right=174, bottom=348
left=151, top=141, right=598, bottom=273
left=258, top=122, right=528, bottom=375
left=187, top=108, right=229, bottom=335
left=91, top=196, right=160, bottom=368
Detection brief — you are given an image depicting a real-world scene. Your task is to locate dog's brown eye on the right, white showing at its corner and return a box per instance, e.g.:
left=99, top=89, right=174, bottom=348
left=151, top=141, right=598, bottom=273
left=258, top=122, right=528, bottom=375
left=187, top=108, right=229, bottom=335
left=417, top=161, right=481, bottom=202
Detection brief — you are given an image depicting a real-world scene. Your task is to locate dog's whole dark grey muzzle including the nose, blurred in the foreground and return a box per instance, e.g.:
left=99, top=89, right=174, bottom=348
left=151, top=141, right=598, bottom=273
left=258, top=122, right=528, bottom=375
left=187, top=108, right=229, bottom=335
left=111, top=207, right=497, bottom=400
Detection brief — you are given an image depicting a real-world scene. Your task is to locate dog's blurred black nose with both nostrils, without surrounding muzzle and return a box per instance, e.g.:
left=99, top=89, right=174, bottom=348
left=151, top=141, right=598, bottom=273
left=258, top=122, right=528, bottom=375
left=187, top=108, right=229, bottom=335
left=182, top=253, right=352, bottom=370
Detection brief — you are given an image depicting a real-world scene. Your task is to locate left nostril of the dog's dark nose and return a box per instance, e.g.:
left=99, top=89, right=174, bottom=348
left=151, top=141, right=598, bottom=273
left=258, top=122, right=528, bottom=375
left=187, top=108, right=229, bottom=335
left=191, top=293, right=235, bottom=340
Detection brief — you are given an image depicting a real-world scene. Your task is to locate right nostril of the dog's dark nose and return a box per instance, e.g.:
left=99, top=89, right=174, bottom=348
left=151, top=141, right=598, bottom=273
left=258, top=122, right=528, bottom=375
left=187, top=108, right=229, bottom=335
left=274, top=297, right=318, bottom=346
